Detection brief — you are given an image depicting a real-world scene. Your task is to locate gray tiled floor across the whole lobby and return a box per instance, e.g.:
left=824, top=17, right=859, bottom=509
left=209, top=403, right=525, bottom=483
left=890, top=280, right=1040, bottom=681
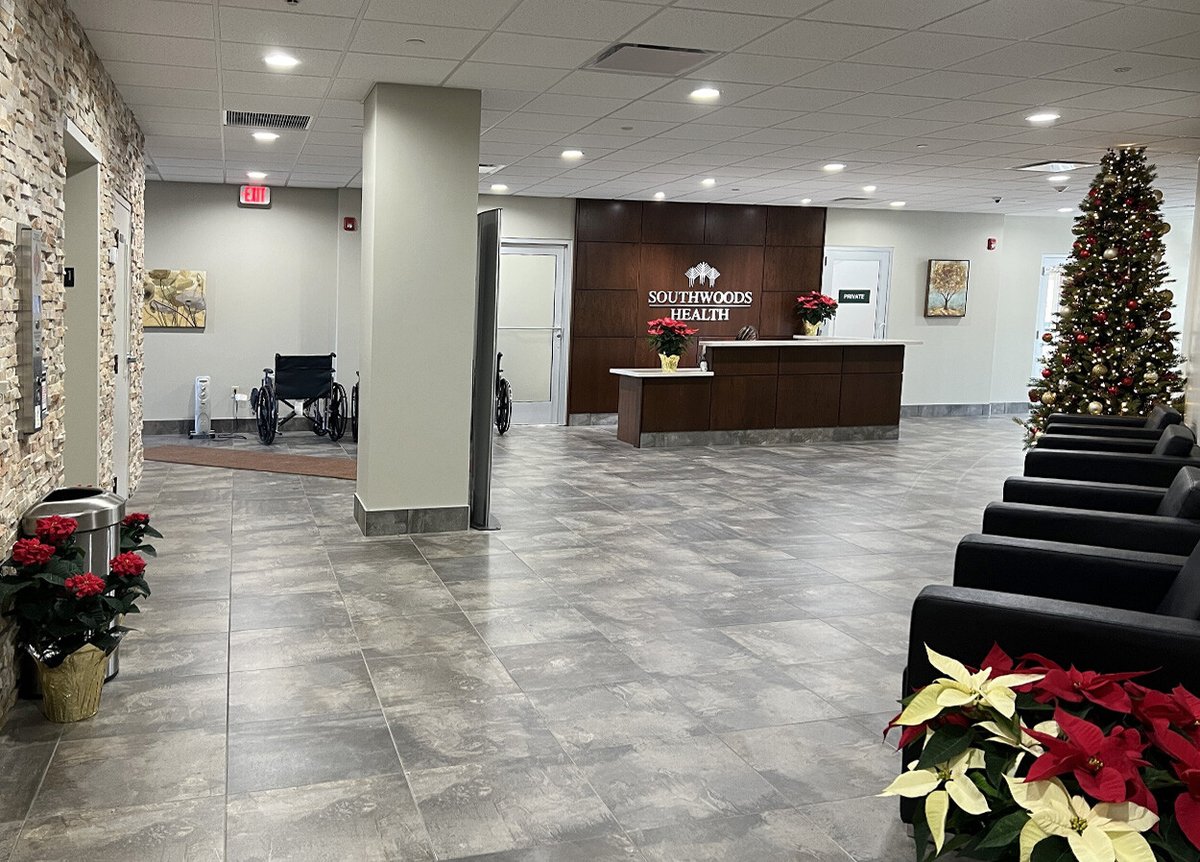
left=0, top=418, right=1020, bottom=862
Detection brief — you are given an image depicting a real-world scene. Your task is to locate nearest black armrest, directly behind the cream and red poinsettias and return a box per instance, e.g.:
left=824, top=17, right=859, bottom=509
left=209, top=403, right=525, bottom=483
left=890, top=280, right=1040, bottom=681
left=907, top=586, right=1200, bottom=690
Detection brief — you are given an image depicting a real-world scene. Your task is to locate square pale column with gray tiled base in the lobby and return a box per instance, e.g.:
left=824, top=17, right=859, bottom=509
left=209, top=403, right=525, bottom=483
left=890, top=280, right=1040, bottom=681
left=354, top=84, right=480, bottom=535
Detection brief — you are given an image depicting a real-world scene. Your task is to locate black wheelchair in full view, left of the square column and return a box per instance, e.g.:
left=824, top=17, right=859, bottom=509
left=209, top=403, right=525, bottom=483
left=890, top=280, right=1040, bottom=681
left=250, top=353, right=349, bottom=445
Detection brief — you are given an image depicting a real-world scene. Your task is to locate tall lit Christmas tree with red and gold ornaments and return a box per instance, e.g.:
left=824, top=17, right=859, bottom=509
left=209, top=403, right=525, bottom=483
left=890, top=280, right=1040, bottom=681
left=1021, top=148, right=1183, bottom=445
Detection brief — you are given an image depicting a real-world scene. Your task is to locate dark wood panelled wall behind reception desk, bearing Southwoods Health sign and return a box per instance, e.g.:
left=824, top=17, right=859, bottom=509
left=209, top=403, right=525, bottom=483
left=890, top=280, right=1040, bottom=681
left=568, top=199, right=826, bottom=415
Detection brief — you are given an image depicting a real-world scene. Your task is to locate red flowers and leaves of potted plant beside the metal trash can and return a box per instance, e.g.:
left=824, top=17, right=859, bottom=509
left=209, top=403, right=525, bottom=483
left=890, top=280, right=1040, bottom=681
left=0, top=513, right=161, bottom=668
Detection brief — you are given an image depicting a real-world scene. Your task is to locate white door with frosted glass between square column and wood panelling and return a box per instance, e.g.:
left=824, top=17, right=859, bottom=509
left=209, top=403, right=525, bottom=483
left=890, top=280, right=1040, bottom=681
left=497, top=243, right=566, bottom=425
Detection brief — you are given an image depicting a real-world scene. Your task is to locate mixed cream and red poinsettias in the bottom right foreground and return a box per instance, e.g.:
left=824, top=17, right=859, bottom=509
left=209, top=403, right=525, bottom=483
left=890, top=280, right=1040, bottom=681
left=883, top=646, right=1200, bottom=862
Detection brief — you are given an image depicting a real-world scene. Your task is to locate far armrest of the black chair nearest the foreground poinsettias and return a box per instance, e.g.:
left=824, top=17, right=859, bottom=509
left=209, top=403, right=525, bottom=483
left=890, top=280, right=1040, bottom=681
left=954, top=534, right=1187, bottom=613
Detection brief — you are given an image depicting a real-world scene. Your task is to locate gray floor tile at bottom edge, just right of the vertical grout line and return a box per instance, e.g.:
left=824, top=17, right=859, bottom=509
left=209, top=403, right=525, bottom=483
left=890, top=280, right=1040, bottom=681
left=228, top=773, right=433, bottom=862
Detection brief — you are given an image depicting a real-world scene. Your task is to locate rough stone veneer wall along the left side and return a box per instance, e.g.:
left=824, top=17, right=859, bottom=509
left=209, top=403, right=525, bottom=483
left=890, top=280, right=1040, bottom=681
left=0, top=0, right=145, bottom=724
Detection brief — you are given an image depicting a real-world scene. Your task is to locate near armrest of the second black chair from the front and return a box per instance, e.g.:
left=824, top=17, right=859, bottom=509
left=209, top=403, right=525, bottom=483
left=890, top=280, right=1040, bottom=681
left=983, top=503, right=1200, bottom=557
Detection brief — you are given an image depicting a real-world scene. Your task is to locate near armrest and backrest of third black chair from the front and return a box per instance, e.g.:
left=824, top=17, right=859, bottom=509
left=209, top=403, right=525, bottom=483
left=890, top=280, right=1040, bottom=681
left=1024, top=425, right=1200, bottom=487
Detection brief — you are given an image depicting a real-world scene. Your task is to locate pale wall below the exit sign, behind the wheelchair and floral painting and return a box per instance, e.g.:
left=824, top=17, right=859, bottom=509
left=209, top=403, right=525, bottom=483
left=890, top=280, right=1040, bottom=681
left=145, top=182, right=343, bottom=420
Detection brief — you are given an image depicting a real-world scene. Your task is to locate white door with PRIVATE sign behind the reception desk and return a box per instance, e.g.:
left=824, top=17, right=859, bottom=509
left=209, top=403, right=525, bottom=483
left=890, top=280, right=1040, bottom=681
left=821, top=247, right=892, bottom=339
